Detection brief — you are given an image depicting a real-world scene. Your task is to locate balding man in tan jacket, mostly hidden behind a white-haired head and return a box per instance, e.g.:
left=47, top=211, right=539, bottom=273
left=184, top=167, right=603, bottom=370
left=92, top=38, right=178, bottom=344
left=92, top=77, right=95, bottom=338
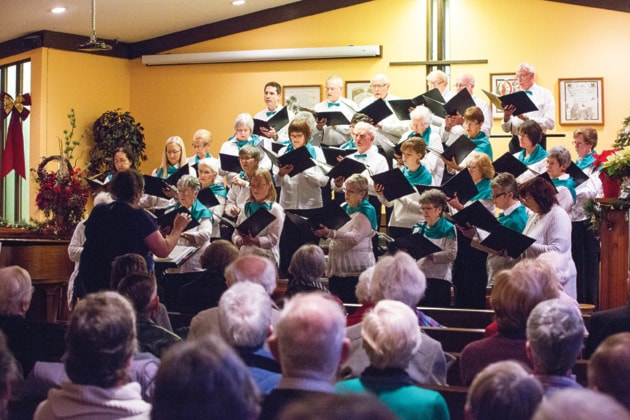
left=188, top=255, right=278, bottom=338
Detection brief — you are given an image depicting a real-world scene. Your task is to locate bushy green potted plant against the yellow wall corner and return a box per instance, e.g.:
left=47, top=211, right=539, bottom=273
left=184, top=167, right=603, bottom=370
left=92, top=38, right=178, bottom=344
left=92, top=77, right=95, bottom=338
left=88, top=109, right=147, bottom=176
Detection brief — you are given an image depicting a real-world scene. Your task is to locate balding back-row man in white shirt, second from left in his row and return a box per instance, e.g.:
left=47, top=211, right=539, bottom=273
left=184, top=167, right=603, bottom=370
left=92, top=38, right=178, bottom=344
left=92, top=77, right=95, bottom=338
left=313, top=76, right=358, bottom=146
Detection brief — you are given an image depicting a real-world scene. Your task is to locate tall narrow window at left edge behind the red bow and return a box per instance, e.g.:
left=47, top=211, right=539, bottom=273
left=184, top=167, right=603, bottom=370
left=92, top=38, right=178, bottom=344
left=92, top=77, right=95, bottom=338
left=0, top=61, right=32, bottom=223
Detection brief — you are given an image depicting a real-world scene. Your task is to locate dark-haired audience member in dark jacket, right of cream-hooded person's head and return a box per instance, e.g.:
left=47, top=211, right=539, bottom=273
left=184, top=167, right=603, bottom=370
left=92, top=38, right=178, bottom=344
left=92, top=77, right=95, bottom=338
left=118, top=272, right=181, bottom=357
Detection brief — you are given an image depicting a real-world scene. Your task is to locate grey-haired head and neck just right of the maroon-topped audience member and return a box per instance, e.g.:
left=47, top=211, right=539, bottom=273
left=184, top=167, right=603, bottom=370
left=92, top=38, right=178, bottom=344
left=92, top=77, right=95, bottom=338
left=525, top=299, right=585, bottom=397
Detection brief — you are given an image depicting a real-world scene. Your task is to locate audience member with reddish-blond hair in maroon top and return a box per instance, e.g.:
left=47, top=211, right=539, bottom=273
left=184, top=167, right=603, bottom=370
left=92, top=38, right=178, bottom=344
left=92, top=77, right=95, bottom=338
left=460, top=260, right=560, bottom=386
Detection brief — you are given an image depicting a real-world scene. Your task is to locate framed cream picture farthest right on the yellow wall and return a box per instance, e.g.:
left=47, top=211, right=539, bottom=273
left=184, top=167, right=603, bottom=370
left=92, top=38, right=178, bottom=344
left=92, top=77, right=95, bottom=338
left=558, top=77, right=604, bottom=125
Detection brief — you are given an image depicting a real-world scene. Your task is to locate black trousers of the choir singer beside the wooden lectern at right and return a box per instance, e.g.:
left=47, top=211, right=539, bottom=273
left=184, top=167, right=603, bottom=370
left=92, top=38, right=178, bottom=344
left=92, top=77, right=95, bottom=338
left=571, top=220, right=600, bottom=305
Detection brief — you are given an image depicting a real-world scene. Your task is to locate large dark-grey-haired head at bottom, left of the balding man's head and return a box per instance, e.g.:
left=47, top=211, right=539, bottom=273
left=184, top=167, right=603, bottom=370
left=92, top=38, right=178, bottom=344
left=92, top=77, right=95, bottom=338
left=151, top=334, right=259, bottom=420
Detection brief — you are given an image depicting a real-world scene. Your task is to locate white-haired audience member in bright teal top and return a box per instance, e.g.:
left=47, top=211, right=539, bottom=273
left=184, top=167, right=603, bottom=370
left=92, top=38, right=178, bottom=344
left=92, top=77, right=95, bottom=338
left=335, top=300, right=449, bottom=420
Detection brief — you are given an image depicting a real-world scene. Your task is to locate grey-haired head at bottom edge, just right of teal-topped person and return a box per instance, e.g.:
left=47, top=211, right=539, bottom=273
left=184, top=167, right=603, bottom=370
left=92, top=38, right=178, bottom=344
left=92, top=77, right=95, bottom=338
left=465, top=360, right=544, bottom=420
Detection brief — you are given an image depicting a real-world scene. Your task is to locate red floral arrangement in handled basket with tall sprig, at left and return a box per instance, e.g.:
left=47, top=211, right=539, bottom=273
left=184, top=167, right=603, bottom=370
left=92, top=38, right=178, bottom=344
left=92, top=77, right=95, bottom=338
left=34, top=109, right=90, bottom=237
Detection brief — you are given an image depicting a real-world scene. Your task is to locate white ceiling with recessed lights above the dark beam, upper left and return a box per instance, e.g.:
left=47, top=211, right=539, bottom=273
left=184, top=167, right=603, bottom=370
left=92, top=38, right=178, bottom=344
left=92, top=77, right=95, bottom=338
left=0, top=0, right=302, bottom=43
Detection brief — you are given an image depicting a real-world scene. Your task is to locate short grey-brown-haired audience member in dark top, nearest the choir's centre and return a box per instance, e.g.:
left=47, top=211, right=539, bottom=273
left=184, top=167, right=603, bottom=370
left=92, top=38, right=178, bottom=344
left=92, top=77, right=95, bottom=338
left=285, top=244, right=328, bottom=297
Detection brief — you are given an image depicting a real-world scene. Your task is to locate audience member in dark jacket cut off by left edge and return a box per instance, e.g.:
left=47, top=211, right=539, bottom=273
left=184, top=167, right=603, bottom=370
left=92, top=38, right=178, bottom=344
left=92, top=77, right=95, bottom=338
left=0, top=265, right=65, bottom=377
